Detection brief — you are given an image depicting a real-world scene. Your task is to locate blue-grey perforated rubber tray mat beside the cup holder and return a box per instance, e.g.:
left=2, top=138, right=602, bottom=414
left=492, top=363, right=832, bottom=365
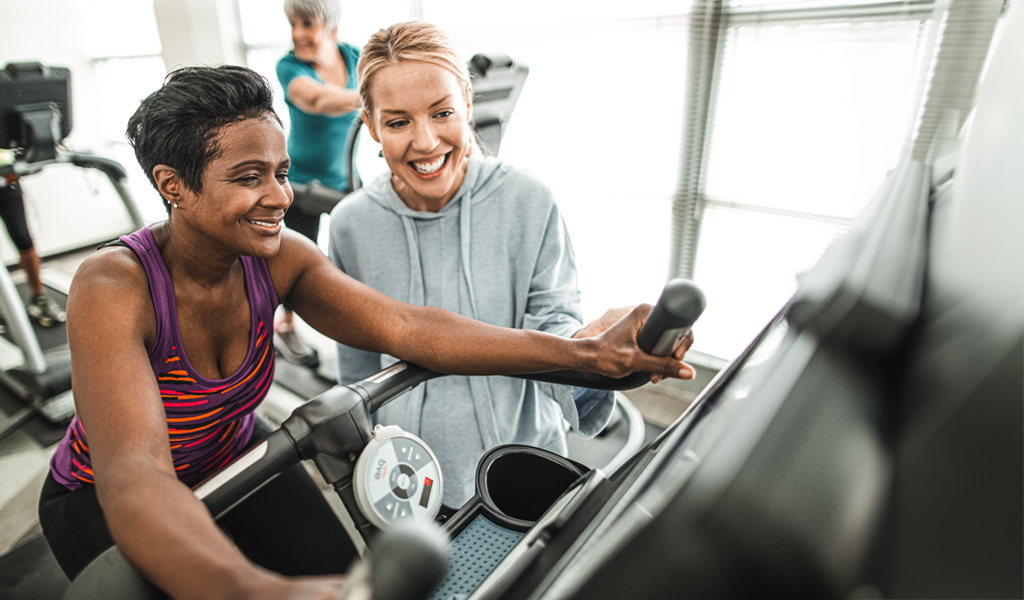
left=430, top=515, right=525, bottom=600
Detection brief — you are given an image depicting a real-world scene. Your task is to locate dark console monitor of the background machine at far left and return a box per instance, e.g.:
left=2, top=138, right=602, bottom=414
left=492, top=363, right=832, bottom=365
left=0, top=62, right=72, bottom=151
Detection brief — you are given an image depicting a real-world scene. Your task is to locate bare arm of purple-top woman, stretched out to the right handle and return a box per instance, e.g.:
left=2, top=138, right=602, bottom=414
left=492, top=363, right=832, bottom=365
left=267, top=231, right=690, bottom=378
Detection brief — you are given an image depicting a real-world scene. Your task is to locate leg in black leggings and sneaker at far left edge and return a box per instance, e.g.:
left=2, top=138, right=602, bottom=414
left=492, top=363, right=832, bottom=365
left=0, top=149, right=65, bottom=327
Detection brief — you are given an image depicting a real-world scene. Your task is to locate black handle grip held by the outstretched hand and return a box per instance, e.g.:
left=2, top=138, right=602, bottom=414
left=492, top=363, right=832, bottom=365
left=517, top=278, right=708, bottom=390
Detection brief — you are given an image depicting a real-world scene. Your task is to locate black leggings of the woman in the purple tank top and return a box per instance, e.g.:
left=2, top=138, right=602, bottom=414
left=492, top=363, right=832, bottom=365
left=39, top=419, right=356, bottom=580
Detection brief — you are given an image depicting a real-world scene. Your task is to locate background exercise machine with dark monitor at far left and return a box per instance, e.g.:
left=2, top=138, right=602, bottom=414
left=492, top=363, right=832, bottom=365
left=0, top=62, right=145, bottom=439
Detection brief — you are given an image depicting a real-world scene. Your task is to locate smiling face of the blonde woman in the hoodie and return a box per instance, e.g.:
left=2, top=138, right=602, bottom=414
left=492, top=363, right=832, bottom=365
left=364, top=60, right=472, bottom=212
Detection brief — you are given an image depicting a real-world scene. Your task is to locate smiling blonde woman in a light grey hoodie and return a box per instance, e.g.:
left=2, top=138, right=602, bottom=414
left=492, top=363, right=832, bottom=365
left=329, top=22, right=692, bottom=509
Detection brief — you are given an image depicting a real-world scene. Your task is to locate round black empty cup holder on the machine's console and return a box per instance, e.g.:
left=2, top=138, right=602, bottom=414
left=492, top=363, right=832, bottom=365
left=477, top=445, right=587, bottom=522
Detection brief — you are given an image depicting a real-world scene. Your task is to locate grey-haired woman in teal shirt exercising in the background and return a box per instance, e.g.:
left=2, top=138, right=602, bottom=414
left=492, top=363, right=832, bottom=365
left=274, top=0, right=359, bottom=368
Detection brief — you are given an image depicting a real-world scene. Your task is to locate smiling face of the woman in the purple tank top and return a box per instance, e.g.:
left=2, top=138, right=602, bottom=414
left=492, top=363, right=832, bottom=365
left=172, top=118, right=292, bottom=258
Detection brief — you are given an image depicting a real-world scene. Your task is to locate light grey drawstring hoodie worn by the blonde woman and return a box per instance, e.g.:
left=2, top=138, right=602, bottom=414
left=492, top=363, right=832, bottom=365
left=330, top=156, right=613, bottom=508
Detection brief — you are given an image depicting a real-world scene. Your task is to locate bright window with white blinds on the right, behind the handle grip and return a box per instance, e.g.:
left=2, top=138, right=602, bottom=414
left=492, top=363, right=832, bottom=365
left=669, top=0, right=1001, bottom=356
